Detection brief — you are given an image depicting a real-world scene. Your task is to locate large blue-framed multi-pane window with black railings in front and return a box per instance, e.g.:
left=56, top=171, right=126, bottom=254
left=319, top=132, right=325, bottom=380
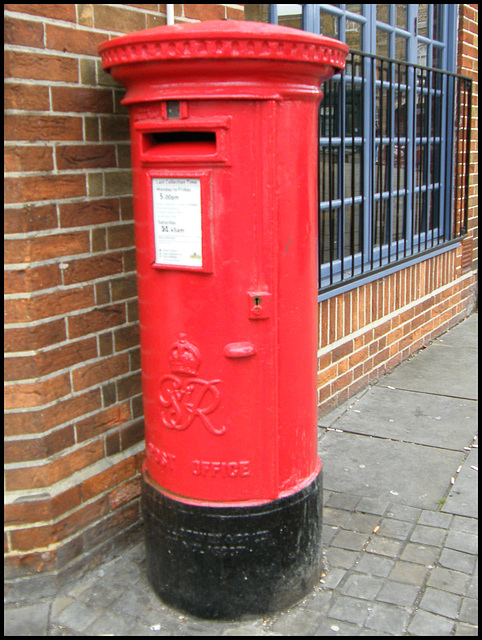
left=258, top=4, right=471, bottom=299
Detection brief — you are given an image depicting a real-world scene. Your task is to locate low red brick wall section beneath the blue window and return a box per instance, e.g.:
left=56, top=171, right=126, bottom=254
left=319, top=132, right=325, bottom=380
left=318, top=258, right=475, bottom=423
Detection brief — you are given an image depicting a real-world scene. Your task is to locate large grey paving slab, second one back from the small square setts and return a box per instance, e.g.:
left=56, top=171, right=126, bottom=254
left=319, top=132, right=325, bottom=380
left=326, top=385, right=477, bottom=451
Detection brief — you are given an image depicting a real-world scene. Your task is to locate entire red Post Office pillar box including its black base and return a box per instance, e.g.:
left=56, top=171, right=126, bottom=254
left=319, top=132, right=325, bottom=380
left=100, top=21, right=348, bottom=618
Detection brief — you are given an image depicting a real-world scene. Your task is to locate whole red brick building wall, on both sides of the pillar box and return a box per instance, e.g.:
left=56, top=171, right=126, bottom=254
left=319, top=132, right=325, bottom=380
left=4, top=4, right=477, bottom=597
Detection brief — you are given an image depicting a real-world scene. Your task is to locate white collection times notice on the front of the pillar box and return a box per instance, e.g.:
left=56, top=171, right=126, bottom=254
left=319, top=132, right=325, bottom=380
left=152, top=178, right=202, bottom=267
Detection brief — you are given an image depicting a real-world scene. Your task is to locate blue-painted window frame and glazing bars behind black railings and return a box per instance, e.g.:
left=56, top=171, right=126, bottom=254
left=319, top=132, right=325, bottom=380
left=270, top=4, right=466, bottom=300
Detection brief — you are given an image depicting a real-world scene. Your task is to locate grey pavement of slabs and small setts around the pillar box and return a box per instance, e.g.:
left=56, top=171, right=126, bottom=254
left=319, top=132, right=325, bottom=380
left=5, top=313, right=478, bottom=636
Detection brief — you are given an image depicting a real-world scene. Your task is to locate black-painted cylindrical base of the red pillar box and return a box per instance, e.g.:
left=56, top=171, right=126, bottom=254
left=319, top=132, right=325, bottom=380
left=142, top=472, right=322, bottom=619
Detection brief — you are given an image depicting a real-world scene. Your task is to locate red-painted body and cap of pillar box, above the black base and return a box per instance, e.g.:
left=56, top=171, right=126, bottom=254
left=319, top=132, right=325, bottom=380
left=100, top=21, right=348, bottom=504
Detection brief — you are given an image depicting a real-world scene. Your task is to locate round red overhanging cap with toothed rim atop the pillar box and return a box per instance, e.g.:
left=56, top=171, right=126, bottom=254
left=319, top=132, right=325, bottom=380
left=99, top=20, right=348, bottom=103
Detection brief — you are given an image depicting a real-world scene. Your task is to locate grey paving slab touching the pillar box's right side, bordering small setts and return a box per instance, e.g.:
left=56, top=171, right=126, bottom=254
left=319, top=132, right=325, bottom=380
left=318, top=431, right=465, bottom=509
